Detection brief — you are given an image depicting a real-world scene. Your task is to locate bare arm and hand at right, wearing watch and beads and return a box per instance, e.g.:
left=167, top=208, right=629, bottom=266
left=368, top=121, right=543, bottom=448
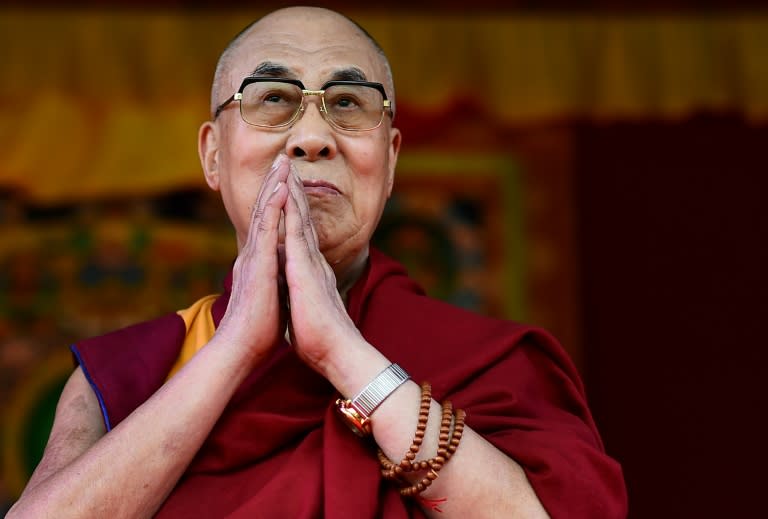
left=285, top=169, right=547, bottom=518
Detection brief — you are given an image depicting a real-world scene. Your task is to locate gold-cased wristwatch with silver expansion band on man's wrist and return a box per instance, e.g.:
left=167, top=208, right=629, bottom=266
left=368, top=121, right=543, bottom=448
left=336, top=364, right=411, bottom=437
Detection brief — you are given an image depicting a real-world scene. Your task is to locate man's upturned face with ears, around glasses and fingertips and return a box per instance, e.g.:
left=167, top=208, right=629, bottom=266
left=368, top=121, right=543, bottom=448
left=200, top=11, right=400, bottom=275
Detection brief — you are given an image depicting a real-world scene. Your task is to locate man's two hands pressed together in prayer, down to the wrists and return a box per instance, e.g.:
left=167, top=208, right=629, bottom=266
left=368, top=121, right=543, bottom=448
left=217, top=156, right=362, bottom=374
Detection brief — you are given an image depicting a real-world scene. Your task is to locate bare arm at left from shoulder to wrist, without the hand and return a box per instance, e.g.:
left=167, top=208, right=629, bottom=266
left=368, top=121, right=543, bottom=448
left=8, top=340, right=256, bottom=518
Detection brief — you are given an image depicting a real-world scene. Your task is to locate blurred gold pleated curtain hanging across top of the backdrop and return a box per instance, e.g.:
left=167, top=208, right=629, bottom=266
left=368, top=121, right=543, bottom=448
left=0, top=9, right=768, bottom=202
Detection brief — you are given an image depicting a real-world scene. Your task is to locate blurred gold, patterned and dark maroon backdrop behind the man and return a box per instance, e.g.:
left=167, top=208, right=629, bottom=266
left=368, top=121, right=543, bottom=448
left=0, top=0, right=768, bottom=518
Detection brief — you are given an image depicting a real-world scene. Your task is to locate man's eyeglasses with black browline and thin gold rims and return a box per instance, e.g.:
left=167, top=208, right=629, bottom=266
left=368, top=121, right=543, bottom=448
left=213, top=77, right=392, bottom=131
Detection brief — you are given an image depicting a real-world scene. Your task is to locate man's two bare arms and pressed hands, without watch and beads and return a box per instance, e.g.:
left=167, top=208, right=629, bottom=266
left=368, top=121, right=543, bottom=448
left=10, top=156, right=547, bottom=518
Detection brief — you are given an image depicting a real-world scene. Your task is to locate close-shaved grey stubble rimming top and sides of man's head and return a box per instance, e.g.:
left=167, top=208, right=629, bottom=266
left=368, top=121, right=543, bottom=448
left=211, top=7, right=395, bottom=120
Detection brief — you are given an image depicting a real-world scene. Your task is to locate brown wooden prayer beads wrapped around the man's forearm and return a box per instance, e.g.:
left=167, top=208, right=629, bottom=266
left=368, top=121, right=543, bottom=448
left=378, top=382, right=466, bottom=496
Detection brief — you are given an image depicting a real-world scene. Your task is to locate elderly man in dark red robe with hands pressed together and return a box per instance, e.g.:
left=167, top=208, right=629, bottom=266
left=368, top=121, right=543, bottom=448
left=9, top=8, right=626, bottom=518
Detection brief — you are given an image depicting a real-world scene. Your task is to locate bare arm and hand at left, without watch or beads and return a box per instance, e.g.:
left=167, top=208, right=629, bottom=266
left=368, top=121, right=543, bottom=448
left=8, top=161, right=287, bottom=519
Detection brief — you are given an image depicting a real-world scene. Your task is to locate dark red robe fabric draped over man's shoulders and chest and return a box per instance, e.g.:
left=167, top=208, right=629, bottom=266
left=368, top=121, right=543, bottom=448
left=72, top=250, right=627, bottom=519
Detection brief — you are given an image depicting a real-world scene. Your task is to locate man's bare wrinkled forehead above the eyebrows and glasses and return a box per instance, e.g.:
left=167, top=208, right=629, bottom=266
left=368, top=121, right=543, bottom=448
left=230, top=15, right=386, bottom=88
